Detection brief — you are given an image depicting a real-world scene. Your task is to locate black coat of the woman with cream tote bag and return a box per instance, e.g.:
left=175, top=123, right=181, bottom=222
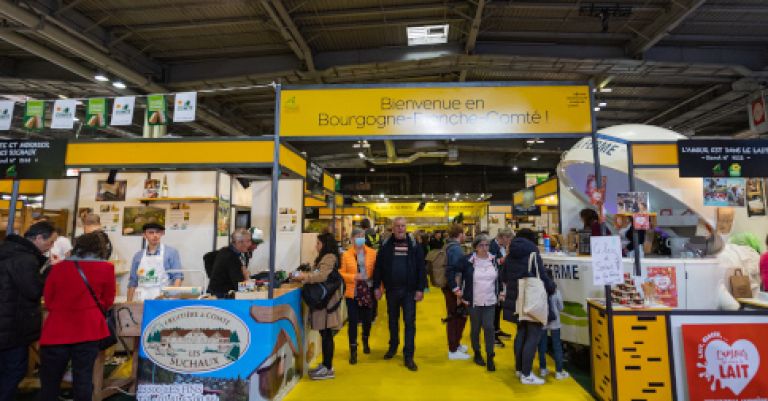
left=500, top=237, right=556, bottom=321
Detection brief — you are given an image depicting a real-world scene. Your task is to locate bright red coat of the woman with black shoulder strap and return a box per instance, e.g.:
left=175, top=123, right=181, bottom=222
left=40, top=259, right=115, bottom=345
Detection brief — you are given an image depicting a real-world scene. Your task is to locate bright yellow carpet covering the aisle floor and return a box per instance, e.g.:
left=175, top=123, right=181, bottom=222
left=285, top=288, right=593, bottom=401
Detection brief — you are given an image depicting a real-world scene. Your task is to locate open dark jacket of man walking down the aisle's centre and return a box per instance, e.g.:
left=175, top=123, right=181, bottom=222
left=373, top=235, right=427, bottom=292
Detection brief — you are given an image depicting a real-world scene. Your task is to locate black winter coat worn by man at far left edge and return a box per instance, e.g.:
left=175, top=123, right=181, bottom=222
left=0, top=234, right=46, bottom=350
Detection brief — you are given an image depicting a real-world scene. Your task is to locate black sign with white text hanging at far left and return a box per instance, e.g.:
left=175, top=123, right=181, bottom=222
left=0, top=140, right=67, bottom=179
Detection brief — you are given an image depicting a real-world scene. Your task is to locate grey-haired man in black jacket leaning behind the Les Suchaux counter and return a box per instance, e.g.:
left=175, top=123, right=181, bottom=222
left=208, top=228, right=255, bottom=298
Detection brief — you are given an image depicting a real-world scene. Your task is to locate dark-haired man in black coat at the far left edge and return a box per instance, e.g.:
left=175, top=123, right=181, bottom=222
left=0, top=221, right=56, bottom=401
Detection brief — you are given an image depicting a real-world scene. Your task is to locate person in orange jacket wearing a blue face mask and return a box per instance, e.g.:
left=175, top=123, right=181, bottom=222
left=339, top=228, right=376, bottom=365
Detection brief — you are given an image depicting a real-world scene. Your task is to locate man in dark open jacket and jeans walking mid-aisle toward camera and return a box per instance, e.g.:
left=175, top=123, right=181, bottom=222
left=373, top=217, right=427, bottom=371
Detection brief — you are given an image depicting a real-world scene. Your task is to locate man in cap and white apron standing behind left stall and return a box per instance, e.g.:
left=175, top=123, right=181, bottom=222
left=128, top=223, right=184, bottom=302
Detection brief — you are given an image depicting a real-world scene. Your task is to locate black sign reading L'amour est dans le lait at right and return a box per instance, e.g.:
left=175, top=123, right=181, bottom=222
left=677, top=139, right=768, bottom=177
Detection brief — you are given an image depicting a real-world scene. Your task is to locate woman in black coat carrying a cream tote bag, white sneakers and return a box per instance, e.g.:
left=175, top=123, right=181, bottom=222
left=502, top=228, right=555, bottom=384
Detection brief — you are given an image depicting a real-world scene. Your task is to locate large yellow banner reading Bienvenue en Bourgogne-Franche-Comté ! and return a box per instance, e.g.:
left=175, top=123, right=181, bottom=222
left=279, top=85, right=593, bottom=137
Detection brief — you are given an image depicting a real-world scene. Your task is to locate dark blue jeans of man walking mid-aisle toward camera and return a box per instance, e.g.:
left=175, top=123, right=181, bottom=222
left=387, top=288, right=416, bottom=361
